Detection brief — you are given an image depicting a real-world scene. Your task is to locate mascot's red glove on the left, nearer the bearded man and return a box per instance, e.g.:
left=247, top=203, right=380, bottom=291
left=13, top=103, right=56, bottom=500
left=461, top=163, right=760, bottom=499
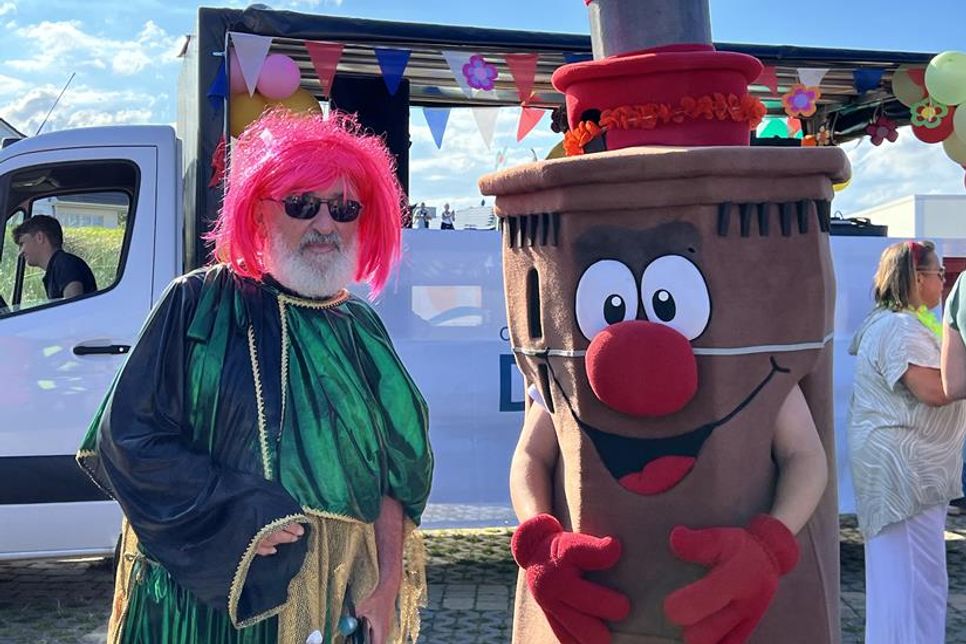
left=510, top=514, right=630, bottom=644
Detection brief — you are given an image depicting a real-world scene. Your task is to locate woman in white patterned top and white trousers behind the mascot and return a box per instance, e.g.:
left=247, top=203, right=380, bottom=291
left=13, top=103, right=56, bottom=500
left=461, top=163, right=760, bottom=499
left=847, top=241, right=966, bottom=644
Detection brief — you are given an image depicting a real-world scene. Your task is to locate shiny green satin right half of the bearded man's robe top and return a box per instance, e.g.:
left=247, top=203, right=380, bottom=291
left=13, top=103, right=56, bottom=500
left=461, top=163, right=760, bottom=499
left=278, top=297, right=433, bottom=523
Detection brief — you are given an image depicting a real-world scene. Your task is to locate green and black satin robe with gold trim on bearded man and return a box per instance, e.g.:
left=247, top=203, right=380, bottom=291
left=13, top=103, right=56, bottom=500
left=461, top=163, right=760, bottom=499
left=78, top=266, right=433, bottom=644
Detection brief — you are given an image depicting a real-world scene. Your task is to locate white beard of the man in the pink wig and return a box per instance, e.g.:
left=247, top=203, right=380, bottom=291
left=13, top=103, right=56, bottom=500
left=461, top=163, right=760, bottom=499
left=265, top=230, right=358, bottom=297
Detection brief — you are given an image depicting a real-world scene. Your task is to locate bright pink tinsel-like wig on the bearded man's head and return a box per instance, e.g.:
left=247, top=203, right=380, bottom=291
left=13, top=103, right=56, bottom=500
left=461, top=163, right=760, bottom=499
left=208, top=109, right=403, bottom=296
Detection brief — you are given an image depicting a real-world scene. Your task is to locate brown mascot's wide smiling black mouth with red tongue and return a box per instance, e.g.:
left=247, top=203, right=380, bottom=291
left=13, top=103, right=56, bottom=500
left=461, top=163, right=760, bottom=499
left=574, top=358, right=789, bottom=496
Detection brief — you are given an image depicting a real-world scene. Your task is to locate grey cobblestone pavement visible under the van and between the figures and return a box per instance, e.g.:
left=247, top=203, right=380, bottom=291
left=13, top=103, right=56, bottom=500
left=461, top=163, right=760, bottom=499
left=0, top=517, right=966, bottom=644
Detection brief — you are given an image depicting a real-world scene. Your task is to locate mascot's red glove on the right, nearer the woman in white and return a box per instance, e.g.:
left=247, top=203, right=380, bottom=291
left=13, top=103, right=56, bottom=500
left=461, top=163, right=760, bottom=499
left=664, top=514, right=798, bottom=644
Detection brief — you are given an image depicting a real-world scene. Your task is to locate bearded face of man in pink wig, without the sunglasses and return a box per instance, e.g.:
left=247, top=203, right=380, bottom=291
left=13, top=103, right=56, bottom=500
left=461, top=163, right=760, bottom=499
left=260, top=182, right=365, bottom=297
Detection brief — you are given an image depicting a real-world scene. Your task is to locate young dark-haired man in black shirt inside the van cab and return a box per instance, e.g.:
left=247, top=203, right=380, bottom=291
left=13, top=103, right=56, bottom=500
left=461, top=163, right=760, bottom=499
left=13, top=215, right=97, bottom=300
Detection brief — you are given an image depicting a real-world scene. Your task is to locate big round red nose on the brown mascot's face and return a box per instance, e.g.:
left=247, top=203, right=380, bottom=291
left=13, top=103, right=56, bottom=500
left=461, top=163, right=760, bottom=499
left=585, top=321, right=698, bottom=417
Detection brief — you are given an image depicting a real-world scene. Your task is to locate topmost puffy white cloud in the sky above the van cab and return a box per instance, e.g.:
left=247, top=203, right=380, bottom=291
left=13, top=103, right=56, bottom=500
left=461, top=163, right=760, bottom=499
left=6, top=20, right=181, bottom=75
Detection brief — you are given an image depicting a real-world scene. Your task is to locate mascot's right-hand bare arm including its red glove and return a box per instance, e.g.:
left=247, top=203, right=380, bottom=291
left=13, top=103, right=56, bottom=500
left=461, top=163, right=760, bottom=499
left=664, top=385, right=828, bottom=644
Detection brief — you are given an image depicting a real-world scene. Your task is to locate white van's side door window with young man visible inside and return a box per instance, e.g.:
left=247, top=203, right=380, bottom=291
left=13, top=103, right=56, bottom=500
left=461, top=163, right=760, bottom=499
left=0, top=161, right=139, bottom=316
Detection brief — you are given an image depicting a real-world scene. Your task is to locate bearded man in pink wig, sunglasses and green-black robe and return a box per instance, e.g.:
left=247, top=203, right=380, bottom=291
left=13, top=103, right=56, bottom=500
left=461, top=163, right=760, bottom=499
left=78, top=111, right=433, bottom=644
